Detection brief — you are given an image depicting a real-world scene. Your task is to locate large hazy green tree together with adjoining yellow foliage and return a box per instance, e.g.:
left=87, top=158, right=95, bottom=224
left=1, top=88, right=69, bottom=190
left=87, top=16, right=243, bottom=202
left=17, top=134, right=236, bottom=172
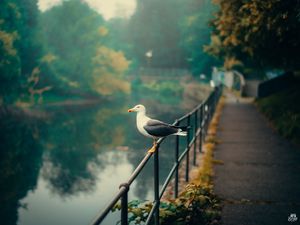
left=41, top=0, right=130, bottom=96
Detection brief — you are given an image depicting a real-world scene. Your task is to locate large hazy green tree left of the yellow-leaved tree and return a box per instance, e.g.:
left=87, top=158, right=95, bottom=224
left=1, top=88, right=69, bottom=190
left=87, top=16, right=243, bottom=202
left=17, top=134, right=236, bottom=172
left=41, top=0, right=105, bottom=90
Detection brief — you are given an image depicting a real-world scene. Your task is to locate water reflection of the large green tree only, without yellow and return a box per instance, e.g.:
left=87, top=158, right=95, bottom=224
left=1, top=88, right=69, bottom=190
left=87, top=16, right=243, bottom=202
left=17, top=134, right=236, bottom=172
left=42, top=110, right=97, bottom=196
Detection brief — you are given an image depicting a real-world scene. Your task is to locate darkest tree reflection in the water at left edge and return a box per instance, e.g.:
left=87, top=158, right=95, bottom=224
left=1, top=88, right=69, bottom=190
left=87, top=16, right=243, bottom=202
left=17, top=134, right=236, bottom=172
left=0, top=115, right=42, bottom=225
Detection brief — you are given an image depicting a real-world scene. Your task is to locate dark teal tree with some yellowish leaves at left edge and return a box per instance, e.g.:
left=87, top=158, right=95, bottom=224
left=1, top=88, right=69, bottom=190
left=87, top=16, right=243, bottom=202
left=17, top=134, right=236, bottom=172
left=0, top=0, right=40, bottom=104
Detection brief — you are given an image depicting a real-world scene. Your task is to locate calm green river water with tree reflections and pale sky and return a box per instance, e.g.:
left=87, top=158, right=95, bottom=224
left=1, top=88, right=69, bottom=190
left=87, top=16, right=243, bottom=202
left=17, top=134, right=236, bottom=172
left=0, top=85, right=211, bottom=225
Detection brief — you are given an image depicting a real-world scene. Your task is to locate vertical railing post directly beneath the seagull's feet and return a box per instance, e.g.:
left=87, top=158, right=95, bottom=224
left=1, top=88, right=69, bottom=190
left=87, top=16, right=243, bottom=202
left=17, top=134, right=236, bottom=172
left=153, top=145, right=160, bottom=225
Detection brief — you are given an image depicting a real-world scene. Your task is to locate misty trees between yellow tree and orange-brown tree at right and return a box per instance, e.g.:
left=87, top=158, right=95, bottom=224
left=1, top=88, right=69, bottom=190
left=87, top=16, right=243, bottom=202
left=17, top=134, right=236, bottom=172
left=129, top=0, right=216, bottom=75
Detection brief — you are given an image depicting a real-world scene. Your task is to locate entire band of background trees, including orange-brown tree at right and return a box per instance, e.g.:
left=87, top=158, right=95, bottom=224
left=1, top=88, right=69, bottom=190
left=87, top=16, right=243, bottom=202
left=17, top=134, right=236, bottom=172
left=0, top=0, right=300, bottom=104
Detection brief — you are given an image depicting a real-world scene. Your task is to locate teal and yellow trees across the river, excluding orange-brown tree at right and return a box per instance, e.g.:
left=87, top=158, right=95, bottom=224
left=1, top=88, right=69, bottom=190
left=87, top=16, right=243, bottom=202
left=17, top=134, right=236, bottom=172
left=0, top=0, right=216, bottom=104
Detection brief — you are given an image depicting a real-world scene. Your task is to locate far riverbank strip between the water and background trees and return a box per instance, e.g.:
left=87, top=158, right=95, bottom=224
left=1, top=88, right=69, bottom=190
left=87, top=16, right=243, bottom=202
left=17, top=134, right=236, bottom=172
left=0, top=77, right=211, bottom=122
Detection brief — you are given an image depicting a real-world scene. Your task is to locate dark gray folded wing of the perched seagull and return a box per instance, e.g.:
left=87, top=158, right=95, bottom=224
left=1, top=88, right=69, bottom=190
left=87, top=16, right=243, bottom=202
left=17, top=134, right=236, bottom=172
left=144, top=120, right=178, bottom=137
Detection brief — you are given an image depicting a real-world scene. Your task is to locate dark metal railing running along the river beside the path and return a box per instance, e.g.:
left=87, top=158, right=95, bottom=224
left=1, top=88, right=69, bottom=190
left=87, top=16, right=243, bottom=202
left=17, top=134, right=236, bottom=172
left=91, top=86, right=222, bottom=225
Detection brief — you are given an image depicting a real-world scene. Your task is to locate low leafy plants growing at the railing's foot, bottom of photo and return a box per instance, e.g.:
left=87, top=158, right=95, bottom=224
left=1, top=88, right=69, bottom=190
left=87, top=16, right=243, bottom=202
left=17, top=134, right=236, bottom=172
left=114, top=184, right=220, bottom=225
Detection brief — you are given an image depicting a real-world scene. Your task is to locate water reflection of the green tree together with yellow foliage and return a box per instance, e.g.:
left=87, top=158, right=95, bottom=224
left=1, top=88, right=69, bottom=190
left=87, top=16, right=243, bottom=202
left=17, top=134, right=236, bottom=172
left=38, top=100, right=129, bottom=197
